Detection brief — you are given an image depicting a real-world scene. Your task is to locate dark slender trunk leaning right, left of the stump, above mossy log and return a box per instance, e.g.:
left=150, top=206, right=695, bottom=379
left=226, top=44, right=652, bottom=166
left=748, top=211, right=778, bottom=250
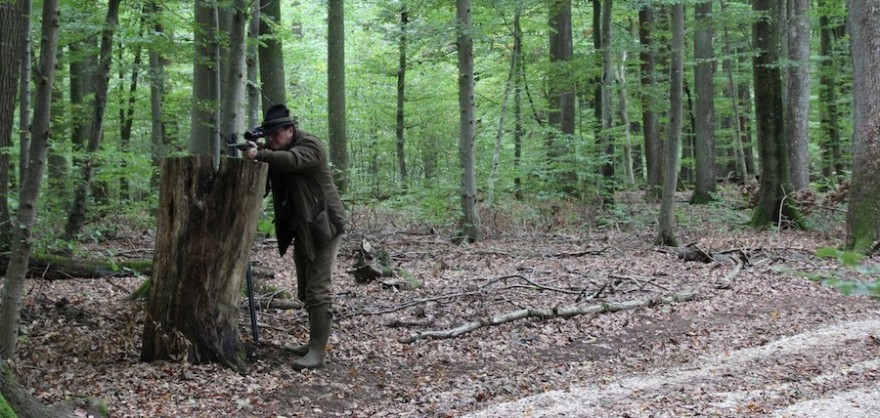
left=64, top=0, right=120, bottom=239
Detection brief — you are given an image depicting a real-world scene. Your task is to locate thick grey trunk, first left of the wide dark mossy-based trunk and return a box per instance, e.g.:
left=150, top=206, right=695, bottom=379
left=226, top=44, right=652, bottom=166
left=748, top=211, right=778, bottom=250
left=691, top=1, right=715, bottom=203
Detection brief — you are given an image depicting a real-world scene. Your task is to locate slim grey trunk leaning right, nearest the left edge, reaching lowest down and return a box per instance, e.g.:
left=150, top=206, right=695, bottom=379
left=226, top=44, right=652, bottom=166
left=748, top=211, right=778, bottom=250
left=0, top=0, right=58, bottom=358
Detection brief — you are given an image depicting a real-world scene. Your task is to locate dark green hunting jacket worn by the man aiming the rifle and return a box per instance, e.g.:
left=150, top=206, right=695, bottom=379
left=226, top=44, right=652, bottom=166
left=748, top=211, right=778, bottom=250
left=257, top=130, right=346, bottom=260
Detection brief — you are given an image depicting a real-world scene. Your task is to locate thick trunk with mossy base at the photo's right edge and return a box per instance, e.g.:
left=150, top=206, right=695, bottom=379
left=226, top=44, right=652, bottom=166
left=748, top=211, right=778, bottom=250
left=846, top=0, right=880, bottom=254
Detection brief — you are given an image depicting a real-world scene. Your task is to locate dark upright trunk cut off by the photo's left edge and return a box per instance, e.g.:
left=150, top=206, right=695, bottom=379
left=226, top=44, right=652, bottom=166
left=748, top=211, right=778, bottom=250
left=0, top=1, right=24, bottom=249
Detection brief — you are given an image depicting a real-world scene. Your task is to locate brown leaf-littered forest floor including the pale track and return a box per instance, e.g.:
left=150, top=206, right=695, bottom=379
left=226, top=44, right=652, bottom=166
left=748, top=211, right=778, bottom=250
left=3, top=191, right=880, bottom=418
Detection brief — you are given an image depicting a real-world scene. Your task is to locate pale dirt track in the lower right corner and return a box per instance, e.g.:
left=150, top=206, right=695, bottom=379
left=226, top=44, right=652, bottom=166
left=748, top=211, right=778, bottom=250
left=466, top=319, right=880, bottom=418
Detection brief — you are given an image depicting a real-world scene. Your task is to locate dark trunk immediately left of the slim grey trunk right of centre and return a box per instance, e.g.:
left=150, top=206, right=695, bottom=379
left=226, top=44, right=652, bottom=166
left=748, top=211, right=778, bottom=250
left=639, top=5, right=663, bottom=200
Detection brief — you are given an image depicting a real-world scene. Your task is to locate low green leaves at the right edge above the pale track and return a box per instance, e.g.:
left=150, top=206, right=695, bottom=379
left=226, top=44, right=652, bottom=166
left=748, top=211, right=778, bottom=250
left=782, top=247, right=880, bottom=298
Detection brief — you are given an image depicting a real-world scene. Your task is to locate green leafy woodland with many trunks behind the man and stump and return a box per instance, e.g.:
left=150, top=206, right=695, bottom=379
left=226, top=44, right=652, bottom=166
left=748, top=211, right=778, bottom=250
left=0, top=0, right=880, bottom=414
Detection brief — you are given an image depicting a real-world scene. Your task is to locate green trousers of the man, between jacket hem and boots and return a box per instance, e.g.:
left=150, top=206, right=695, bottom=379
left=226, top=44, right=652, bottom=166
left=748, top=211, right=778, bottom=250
left=293, top=235, right=341, bottom=311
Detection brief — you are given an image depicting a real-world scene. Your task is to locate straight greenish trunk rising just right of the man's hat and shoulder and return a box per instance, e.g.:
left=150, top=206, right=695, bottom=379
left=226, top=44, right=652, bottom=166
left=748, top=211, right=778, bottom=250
left=327, top=0, right=349, bottom=193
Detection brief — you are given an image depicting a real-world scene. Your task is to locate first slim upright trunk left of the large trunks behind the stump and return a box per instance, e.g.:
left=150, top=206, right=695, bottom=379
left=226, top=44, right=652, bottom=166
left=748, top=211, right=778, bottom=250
left=147, top=0, right=166, bottom=188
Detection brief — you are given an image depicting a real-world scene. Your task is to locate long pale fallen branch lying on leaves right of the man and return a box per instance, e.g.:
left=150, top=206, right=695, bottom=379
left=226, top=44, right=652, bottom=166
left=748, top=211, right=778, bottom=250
left=400, top=292, right=696, bottom=344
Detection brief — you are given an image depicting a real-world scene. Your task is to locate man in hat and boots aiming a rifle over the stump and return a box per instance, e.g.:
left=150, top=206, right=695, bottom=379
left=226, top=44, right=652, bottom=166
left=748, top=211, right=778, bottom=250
left=243, top=105, right=345, bottom=369
